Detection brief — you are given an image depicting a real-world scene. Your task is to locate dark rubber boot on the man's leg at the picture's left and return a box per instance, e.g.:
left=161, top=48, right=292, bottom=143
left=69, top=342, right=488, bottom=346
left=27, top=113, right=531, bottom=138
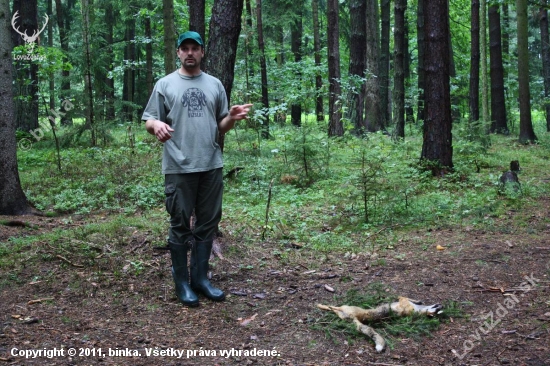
left=168, top=242, right=199, bottom=307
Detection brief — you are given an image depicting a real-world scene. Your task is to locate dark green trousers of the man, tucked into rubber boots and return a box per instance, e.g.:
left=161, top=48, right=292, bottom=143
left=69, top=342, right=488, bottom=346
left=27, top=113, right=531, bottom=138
left=164, top=168, right=223, bottom=244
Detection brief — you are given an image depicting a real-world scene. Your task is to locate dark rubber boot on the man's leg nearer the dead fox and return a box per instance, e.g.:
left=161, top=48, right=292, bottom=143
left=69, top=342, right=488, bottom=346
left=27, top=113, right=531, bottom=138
left=191, top=240, right=225, bottom=301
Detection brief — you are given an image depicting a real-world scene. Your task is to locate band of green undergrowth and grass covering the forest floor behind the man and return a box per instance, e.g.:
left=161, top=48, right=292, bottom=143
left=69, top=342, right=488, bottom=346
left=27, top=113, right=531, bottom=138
left=10, top=116, right=550, bottom=258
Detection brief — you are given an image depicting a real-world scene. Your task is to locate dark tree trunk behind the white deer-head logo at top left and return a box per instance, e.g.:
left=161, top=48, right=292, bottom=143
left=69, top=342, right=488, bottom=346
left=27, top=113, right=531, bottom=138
left=9, top=0, right=39, bottom=131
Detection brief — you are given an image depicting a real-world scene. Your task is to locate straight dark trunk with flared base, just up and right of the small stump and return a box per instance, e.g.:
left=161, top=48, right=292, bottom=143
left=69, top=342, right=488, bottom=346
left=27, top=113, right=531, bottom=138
left=516, top=0, right=537, bottom=143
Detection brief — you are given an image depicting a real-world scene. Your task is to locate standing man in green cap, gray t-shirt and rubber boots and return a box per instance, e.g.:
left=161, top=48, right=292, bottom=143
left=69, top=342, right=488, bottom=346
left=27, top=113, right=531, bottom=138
left=142, top=31, right=252, bottom=306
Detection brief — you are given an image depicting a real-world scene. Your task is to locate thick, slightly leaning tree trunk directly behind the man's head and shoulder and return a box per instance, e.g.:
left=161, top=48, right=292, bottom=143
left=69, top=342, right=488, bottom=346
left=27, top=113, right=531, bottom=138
left=205, top=0, right=244, bottom=151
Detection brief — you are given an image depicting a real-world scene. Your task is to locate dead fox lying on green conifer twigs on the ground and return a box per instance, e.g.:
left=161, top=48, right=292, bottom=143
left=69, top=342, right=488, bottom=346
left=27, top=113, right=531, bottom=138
left=317, top=296, right=443, bottom=352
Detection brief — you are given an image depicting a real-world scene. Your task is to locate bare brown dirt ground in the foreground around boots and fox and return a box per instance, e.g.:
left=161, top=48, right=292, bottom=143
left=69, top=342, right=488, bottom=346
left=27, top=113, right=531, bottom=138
left=0, top=199, right=550, bottom=366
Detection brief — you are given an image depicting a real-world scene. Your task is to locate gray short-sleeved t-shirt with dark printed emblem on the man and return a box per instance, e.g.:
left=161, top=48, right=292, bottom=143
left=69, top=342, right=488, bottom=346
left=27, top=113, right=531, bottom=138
left=141, top=71, right=229, bottom=174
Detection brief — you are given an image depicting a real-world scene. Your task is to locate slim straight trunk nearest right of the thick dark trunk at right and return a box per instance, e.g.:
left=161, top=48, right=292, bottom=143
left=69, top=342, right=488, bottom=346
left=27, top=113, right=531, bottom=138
left=469, top=0, right=480, bottom=122
